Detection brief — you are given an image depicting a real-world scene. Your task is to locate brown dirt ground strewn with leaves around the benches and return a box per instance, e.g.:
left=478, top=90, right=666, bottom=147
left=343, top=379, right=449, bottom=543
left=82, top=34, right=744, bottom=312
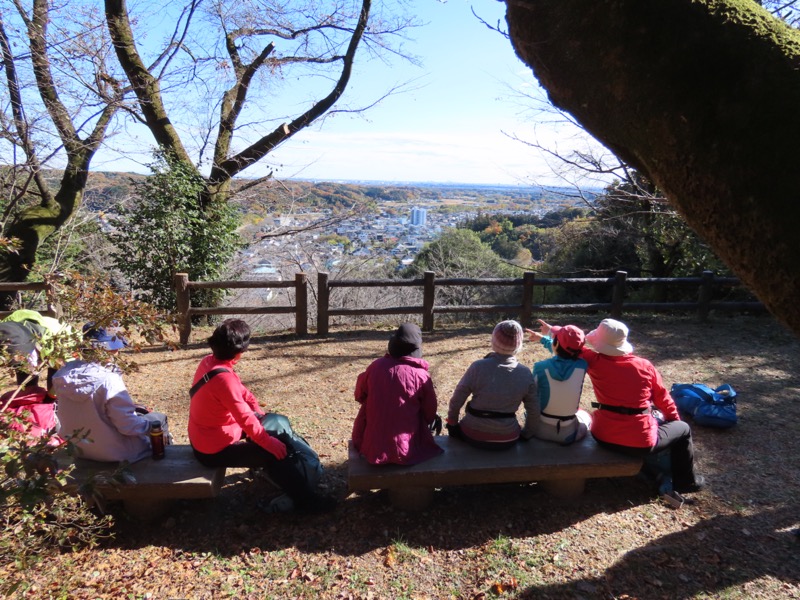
left=0, top=315, right=800, bottom=600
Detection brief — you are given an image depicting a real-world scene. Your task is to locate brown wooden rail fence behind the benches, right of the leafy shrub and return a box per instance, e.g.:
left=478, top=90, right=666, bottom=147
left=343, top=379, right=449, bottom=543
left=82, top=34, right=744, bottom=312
left=175, top=271, right=764, bottom=344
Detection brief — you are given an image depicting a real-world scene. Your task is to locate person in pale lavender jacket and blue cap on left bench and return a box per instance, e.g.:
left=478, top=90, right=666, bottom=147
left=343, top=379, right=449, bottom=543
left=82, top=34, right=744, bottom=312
left=53, top=329, right=169, bottom=462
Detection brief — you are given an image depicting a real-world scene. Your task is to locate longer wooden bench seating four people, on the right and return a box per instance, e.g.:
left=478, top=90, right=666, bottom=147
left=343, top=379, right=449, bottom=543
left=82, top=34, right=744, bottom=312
left=347, top=435, right=642, bottom=510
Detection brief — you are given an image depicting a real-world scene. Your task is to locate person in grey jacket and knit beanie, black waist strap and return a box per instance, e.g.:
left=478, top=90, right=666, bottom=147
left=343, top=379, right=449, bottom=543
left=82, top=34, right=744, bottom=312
left=447, top=321, right=539, bottom=450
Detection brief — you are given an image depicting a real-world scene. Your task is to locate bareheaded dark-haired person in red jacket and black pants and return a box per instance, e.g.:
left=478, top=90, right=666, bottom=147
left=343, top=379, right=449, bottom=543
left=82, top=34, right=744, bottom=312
left=189, top=319, right=336, bottom=512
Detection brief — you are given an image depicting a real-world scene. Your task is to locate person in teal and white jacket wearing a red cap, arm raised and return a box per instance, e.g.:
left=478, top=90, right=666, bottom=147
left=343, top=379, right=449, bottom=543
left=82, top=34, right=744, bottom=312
left=524, top=325, right=592, bottom=445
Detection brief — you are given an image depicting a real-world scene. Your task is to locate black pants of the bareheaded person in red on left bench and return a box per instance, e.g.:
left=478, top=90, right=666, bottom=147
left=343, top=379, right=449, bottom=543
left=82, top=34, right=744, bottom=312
left=194, top=440, right=316, bottom=507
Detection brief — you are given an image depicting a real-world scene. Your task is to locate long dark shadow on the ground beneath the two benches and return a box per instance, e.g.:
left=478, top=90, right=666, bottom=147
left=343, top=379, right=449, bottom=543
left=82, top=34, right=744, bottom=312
left=103, top=465, right=652, bottom=557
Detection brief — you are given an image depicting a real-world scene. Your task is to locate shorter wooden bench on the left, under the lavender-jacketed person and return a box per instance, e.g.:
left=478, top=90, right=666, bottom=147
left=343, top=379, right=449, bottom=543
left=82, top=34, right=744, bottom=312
left=59, top=444, right=225, bottom=520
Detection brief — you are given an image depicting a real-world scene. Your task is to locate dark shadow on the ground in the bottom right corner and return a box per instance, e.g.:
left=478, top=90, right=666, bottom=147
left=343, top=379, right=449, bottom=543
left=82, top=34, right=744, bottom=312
left=519, top=507, right=800, bottom=599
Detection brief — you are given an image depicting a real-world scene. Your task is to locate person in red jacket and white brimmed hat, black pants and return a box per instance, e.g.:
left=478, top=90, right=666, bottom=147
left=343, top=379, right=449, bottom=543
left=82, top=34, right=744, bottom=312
left=539, top=319, right=705, bottom=493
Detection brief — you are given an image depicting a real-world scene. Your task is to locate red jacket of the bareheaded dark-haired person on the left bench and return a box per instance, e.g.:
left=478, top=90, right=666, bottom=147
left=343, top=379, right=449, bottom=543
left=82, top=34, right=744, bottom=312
left=189, top=354, right=270, bottom=454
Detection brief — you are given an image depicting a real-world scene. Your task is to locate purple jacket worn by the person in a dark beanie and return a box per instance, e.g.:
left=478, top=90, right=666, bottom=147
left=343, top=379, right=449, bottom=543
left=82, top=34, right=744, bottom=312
left=353, top=354, right=442, bottom=465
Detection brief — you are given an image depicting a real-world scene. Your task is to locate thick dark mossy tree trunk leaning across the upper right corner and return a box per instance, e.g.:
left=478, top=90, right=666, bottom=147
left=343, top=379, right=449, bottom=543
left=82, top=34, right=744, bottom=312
left=507, top=0, right=800, bottom=335
